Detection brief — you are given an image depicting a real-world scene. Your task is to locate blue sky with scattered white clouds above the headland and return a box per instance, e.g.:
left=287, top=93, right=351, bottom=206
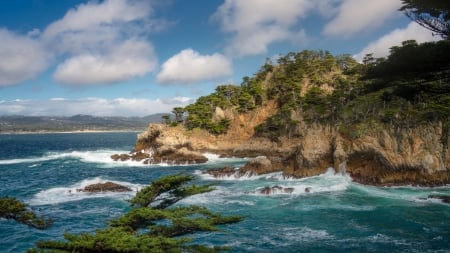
left=0, top=0, right=439, bottom=116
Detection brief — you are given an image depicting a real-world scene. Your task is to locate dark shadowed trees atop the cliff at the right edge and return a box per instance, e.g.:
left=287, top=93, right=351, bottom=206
left=362, top=40, right=450, bottom=125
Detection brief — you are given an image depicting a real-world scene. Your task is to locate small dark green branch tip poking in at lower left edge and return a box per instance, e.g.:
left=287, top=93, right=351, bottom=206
left=0, top=197, right=53, bottom=229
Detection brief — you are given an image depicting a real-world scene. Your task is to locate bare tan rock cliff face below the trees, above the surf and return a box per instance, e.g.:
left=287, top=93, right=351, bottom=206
left=129, top=103, right=450, bottom=185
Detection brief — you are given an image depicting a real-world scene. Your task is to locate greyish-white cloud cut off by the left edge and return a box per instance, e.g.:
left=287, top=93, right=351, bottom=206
left=0, top=29, right=49, bottom=87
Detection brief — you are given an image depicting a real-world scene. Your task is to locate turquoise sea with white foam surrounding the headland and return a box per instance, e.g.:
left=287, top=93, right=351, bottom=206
left=0, top=133, right=450, bottom=252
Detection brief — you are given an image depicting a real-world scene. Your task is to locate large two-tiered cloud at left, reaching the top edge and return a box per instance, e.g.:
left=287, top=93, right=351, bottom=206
left=42, top=0, right=157, bottom=85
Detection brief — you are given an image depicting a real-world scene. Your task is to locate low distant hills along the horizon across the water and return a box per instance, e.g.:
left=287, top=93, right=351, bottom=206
left=0, top=113, right=164, bottom=133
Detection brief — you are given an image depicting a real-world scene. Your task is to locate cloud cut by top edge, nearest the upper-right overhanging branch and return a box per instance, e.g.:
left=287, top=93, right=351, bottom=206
left=323, top=0, right=401, bottom=37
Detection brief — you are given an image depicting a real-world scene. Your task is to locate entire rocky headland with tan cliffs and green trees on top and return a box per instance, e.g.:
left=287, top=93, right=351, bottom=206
left=113, top=43, right=450, bottom=186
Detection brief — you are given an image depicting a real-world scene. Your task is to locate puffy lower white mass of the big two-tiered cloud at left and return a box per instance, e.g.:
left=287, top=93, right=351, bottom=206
left=53, top=40, right=157, bottom=85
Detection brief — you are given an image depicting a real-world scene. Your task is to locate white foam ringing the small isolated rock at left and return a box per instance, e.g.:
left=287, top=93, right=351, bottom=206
left=29, top=177, right=142, bottom=205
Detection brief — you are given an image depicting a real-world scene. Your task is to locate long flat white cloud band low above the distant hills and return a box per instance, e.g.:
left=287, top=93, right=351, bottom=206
left=0, top=97, right=192, bottom=117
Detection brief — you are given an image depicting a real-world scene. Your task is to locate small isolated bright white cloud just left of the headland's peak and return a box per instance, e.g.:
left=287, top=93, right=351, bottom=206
left=156, top=49, right=232, bottom=83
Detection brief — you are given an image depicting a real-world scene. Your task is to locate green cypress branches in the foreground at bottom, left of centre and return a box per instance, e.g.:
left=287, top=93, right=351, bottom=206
left=28, top=174, right=242, bottom=253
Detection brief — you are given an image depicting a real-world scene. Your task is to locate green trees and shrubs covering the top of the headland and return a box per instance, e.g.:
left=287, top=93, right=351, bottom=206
left=167, top=40, right=450, bottom=140
